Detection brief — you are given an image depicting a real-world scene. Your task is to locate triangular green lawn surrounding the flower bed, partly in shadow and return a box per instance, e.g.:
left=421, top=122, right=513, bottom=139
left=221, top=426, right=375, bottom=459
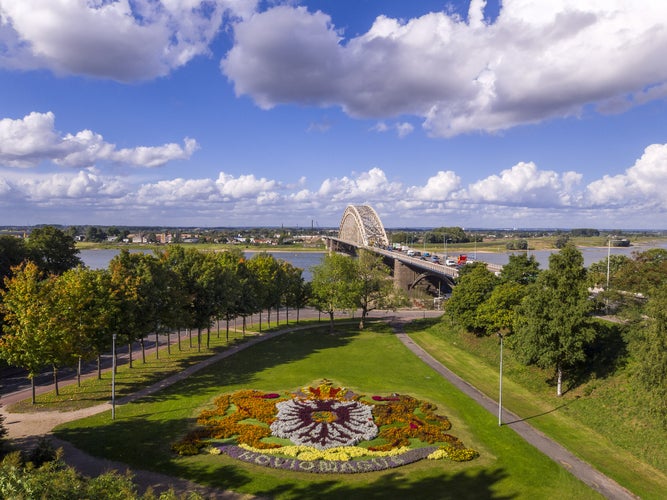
left=55, top=323, right=600, bottom=499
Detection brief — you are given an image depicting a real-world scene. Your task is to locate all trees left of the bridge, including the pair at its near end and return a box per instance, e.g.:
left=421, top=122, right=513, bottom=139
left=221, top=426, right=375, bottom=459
left=0, top=227, right=407, bottom=402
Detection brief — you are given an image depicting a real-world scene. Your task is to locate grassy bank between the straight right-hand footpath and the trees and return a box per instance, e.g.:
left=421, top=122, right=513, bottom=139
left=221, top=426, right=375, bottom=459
left=410, top=320, right=667, bottom=499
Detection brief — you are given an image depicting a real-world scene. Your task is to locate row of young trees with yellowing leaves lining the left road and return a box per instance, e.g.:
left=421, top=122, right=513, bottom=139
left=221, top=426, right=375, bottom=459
left=0, top=246, right=309, bottom=402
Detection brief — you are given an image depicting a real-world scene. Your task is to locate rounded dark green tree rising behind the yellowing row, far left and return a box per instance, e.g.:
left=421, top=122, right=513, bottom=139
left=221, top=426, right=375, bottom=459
left=27, top=226, right=82, bottom=274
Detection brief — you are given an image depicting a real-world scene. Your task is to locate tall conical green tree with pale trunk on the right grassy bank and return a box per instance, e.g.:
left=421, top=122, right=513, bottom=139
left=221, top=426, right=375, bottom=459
left=510, top=244, right=595, bottom=396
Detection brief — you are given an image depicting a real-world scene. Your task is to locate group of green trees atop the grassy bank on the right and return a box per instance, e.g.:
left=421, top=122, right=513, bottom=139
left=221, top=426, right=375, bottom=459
left=446, top=243, right=667, bottom=424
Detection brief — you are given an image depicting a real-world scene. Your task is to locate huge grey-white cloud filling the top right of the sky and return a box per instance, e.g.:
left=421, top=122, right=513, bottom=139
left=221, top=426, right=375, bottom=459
left=221, top=0, right=667, bottom=137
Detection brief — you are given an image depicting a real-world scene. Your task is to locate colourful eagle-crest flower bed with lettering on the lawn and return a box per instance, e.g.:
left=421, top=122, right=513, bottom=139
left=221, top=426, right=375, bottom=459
left=172, top=380, right=479, bottom=474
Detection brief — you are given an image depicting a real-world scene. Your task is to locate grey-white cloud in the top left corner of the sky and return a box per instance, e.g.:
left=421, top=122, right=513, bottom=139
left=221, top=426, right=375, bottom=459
left=0, top=0, right=257, bottom=81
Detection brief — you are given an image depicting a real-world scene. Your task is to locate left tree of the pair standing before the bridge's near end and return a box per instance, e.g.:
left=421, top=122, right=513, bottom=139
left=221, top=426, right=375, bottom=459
left=311, top=253, right=359, bottom=333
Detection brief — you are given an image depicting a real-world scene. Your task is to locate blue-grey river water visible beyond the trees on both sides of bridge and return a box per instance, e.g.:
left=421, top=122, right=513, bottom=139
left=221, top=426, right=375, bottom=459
left=79, top=241, right=667, bottom=281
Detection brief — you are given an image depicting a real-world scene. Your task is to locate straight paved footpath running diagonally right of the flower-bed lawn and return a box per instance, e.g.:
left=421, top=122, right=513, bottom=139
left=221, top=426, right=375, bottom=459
left=393, top=322, right=638, bottom=500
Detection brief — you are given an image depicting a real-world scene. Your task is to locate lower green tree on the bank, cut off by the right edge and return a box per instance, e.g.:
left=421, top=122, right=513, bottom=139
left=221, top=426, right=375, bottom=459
left=629, top=285, right=667, bottom=427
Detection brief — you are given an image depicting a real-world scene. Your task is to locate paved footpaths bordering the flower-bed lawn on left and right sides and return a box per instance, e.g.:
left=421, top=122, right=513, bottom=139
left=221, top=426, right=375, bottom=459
left=0, top=311, right=637, bottom=500
